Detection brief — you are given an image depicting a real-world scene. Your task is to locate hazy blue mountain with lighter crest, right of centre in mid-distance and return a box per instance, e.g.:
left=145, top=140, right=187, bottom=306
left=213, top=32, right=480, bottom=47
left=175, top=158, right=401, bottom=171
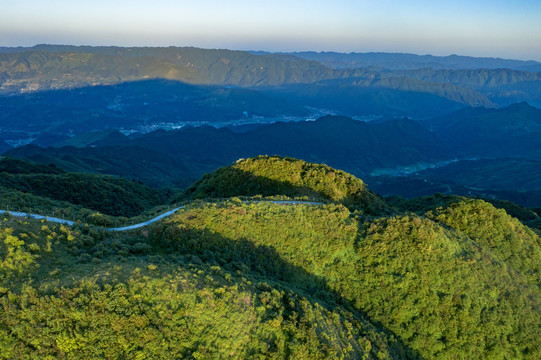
left=269, top=74, right=495, bottom=118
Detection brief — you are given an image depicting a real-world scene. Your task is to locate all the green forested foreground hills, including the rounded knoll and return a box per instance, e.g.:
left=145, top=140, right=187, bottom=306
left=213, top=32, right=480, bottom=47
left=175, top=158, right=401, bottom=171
left=0, top=157, right=541, bottom=359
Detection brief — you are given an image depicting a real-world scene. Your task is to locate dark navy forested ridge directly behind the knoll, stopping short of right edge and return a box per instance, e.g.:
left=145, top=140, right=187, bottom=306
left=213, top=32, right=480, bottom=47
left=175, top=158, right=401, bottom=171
left=5, top=116, right=446, bottom=186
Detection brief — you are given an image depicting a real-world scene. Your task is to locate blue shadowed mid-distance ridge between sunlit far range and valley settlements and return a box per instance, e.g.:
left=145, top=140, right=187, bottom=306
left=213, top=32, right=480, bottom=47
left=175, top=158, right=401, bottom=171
left=0, top=75, right=494, bottom=136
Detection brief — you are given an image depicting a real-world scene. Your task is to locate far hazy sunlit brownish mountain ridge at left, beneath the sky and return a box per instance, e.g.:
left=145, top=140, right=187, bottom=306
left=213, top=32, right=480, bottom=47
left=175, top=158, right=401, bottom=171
left=0, top=45, right=352, bottom=92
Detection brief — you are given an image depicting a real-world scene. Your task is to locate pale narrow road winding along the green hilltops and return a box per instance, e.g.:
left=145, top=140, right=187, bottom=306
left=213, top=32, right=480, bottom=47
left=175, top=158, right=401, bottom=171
left=0, top=200, right=324, bottom=231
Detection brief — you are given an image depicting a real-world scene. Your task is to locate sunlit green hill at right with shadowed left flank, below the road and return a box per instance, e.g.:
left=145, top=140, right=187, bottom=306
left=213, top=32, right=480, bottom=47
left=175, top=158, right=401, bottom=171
left=154, top=201, right=541, bottom=359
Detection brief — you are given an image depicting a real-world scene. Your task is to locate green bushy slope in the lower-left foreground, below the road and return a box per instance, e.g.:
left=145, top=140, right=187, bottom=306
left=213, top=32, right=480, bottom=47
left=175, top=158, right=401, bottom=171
left=0, top=207, right=412, bottom=359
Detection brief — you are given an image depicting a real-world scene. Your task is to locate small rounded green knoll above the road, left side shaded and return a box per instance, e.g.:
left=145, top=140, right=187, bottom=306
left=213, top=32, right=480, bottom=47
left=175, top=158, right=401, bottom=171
left=184, top=156, right=388, bottom=214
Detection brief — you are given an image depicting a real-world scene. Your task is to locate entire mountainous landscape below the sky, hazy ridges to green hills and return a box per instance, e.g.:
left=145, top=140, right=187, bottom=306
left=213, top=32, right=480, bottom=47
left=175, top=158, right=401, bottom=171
left=0, top=45, right=541, bottom=360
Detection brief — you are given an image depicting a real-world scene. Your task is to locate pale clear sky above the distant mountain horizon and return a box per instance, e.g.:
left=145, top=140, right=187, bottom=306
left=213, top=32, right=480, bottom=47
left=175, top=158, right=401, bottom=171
left=0, top=0, right=541, bottom=61
